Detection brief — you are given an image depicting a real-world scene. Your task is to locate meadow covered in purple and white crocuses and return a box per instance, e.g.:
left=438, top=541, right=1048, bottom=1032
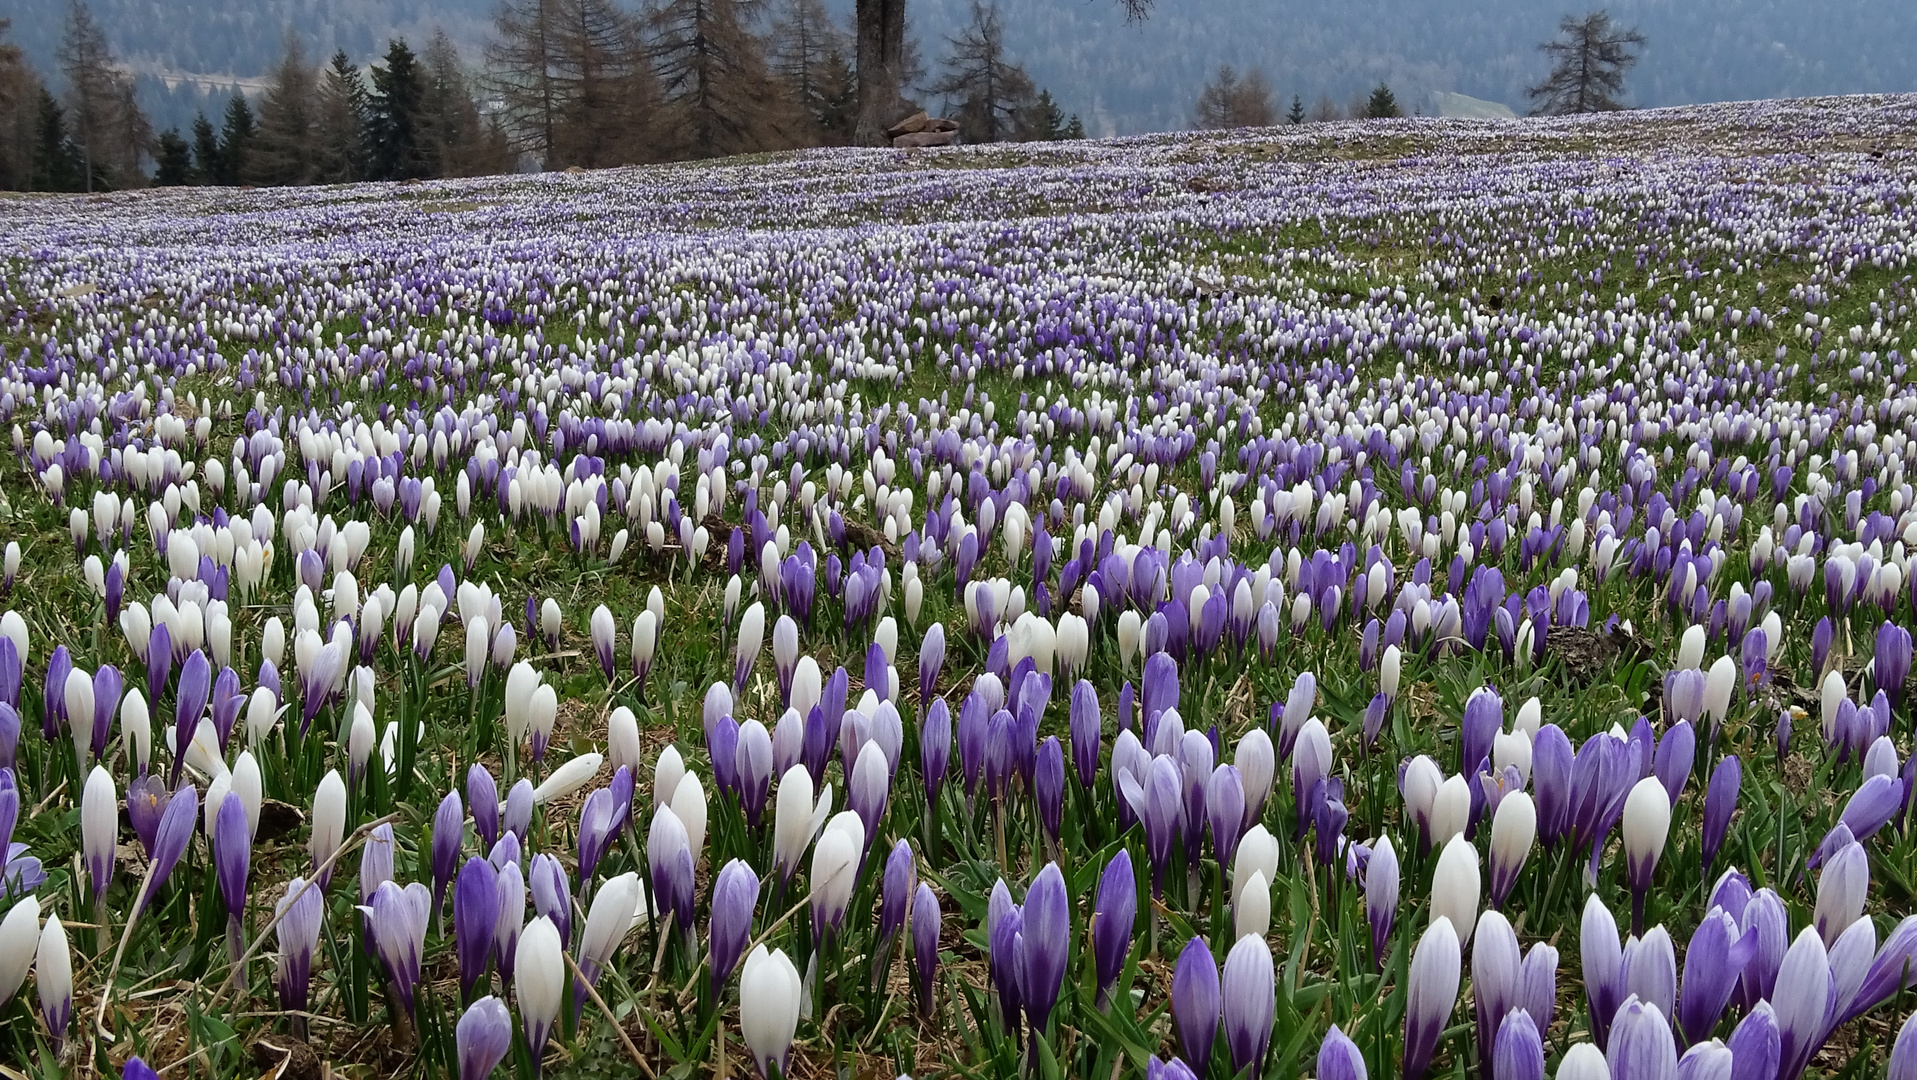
left=0, top=98, right=1917, bottom=1080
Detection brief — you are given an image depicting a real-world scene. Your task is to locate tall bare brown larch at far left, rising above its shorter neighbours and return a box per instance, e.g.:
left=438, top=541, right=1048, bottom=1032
left=59, top=0, right=153, bottom=192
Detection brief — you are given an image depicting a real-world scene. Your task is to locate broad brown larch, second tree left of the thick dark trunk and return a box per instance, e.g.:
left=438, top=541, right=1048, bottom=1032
left=652, top=0, right=797, bottom=157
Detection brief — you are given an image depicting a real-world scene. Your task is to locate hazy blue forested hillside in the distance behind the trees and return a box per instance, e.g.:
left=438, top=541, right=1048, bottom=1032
left=6, top=0, right=1917, bottom=134
